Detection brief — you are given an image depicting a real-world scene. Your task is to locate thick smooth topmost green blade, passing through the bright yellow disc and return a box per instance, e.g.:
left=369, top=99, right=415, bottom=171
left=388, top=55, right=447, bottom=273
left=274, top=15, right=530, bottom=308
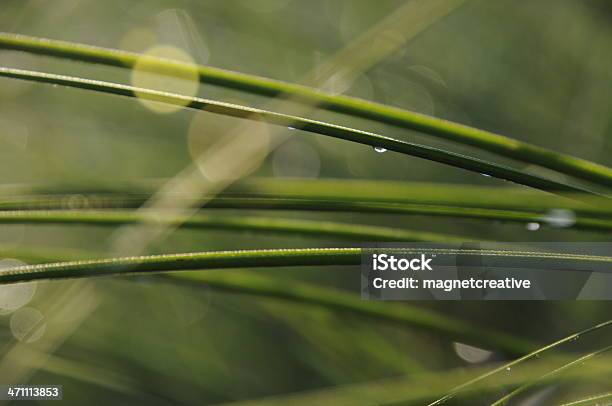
left=0, top=33, right=612, bottom=187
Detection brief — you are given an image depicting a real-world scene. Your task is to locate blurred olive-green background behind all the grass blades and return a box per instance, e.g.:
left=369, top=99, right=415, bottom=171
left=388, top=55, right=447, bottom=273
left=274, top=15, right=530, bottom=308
left=0, top=0, right=612, bottom=404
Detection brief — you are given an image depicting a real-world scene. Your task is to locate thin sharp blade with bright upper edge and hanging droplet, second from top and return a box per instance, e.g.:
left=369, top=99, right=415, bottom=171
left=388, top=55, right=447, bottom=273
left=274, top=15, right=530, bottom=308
left=0, top=68, right=595, bottom=194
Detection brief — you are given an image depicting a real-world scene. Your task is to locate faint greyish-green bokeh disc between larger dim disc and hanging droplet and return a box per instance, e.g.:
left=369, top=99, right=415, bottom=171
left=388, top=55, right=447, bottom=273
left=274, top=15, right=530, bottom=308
left=272, top=140, right=321, bottom=178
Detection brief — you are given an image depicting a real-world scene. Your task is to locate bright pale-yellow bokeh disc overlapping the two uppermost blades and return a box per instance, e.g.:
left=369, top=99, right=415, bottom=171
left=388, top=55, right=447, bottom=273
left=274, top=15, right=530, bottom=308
left=132, top=45, right=199, bottom=113
